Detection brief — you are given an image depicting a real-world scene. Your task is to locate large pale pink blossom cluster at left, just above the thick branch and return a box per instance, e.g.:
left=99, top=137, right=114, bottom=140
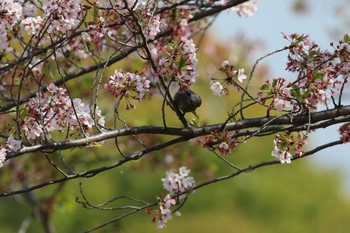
left=21, top=83, right=104, bottom=140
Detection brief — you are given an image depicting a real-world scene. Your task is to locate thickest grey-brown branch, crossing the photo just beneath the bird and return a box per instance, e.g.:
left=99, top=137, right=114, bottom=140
left=6, top=105, right=350, bottom=160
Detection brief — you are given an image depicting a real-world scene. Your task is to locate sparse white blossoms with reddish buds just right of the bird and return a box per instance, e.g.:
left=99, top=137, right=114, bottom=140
left=210, top=60, right=247, bottom=96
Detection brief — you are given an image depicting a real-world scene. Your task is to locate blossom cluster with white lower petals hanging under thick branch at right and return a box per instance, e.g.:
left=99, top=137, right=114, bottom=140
left=271, top=132, right=307, bottom=163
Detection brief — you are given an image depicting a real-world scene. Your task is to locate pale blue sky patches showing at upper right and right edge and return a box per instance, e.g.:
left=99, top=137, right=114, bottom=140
left=213, top=0, right=350, bottom=193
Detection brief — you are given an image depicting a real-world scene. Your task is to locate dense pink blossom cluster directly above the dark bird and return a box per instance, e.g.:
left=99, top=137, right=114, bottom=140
left=156, top=36, right=198, bottom=87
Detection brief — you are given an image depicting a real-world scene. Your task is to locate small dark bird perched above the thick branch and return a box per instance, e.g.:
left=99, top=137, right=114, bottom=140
left=174, top=88, right=202, bottom=119
